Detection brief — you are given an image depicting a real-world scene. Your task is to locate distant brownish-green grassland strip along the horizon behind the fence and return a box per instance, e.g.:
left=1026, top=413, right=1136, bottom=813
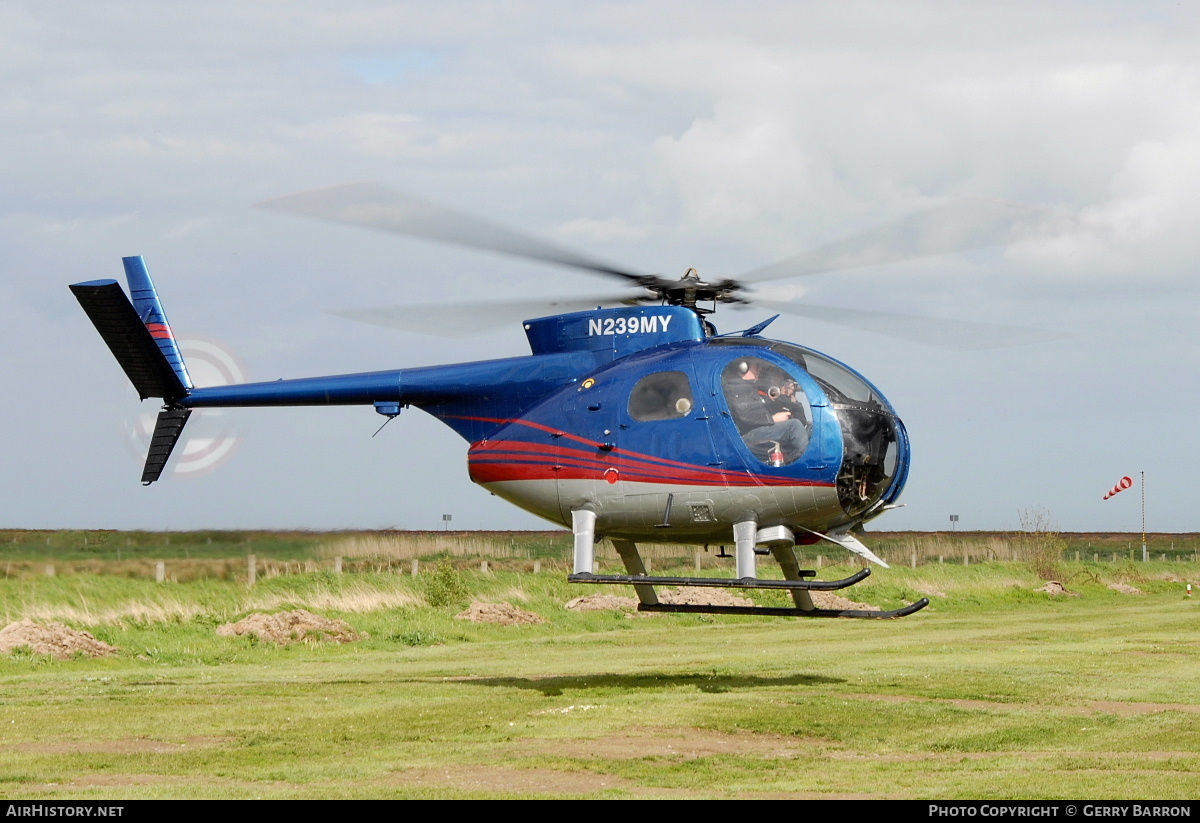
left=0, top=529, right=1200, bottom=579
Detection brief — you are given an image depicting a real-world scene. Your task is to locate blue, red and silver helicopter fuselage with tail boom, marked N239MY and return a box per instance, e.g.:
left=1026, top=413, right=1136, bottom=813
left=174, top=306, right=908, bottom=543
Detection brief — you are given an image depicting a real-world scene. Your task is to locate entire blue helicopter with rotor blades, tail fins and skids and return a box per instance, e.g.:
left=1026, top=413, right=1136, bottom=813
left=70, top=182, right=1044, bottom=619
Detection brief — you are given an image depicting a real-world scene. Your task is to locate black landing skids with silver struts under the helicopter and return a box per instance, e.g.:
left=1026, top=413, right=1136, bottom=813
left=566, top=510, right=929, bottom=620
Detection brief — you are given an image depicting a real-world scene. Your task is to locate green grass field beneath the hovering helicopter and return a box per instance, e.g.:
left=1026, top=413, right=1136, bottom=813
left=0, top=543, right=1200, bottom=799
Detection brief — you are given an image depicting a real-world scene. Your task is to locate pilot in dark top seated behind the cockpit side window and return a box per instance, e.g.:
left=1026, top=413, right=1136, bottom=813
left=725, top=359, right=809, bottom=463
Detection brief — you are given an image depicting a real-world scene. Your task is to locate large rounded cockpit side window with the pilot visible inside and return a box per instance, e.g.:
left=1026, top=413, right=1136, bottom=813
left=721, top=358, right=812, bottom=465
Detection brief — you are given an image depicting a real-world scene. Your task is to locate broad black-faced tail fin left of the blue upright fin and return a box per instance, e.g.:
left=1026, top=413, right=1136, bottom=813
left=71, top=280, right=187, bottom=403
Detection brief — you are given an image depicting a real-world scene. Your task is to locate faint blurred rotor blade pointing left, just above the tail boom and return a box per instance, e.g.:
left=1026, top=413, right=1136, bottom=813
left=329, top=294, right=642, bottom=337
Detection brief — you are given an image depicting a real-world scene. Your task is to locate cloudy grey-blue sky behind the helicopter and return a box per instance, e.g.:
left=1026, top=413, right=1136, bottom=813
left=0, top=0, right=1200, bottom=531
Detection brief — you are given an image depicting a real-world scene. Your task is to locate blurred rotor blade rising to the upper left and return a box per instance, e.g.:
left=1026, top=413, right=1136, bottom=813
left=258, top=181, right=642, bottom=282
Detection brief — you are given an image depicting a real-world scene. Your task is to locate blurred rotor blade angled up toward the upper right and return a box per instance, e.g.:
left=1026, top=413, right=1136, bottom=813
left=736, top=199, right=1048, bottom=283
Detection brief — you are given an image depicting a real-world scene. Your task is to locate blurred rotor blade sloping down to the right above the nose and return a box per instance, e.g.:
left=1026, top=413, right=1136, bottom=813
left=751, top=298, right=1068, bottom=352
